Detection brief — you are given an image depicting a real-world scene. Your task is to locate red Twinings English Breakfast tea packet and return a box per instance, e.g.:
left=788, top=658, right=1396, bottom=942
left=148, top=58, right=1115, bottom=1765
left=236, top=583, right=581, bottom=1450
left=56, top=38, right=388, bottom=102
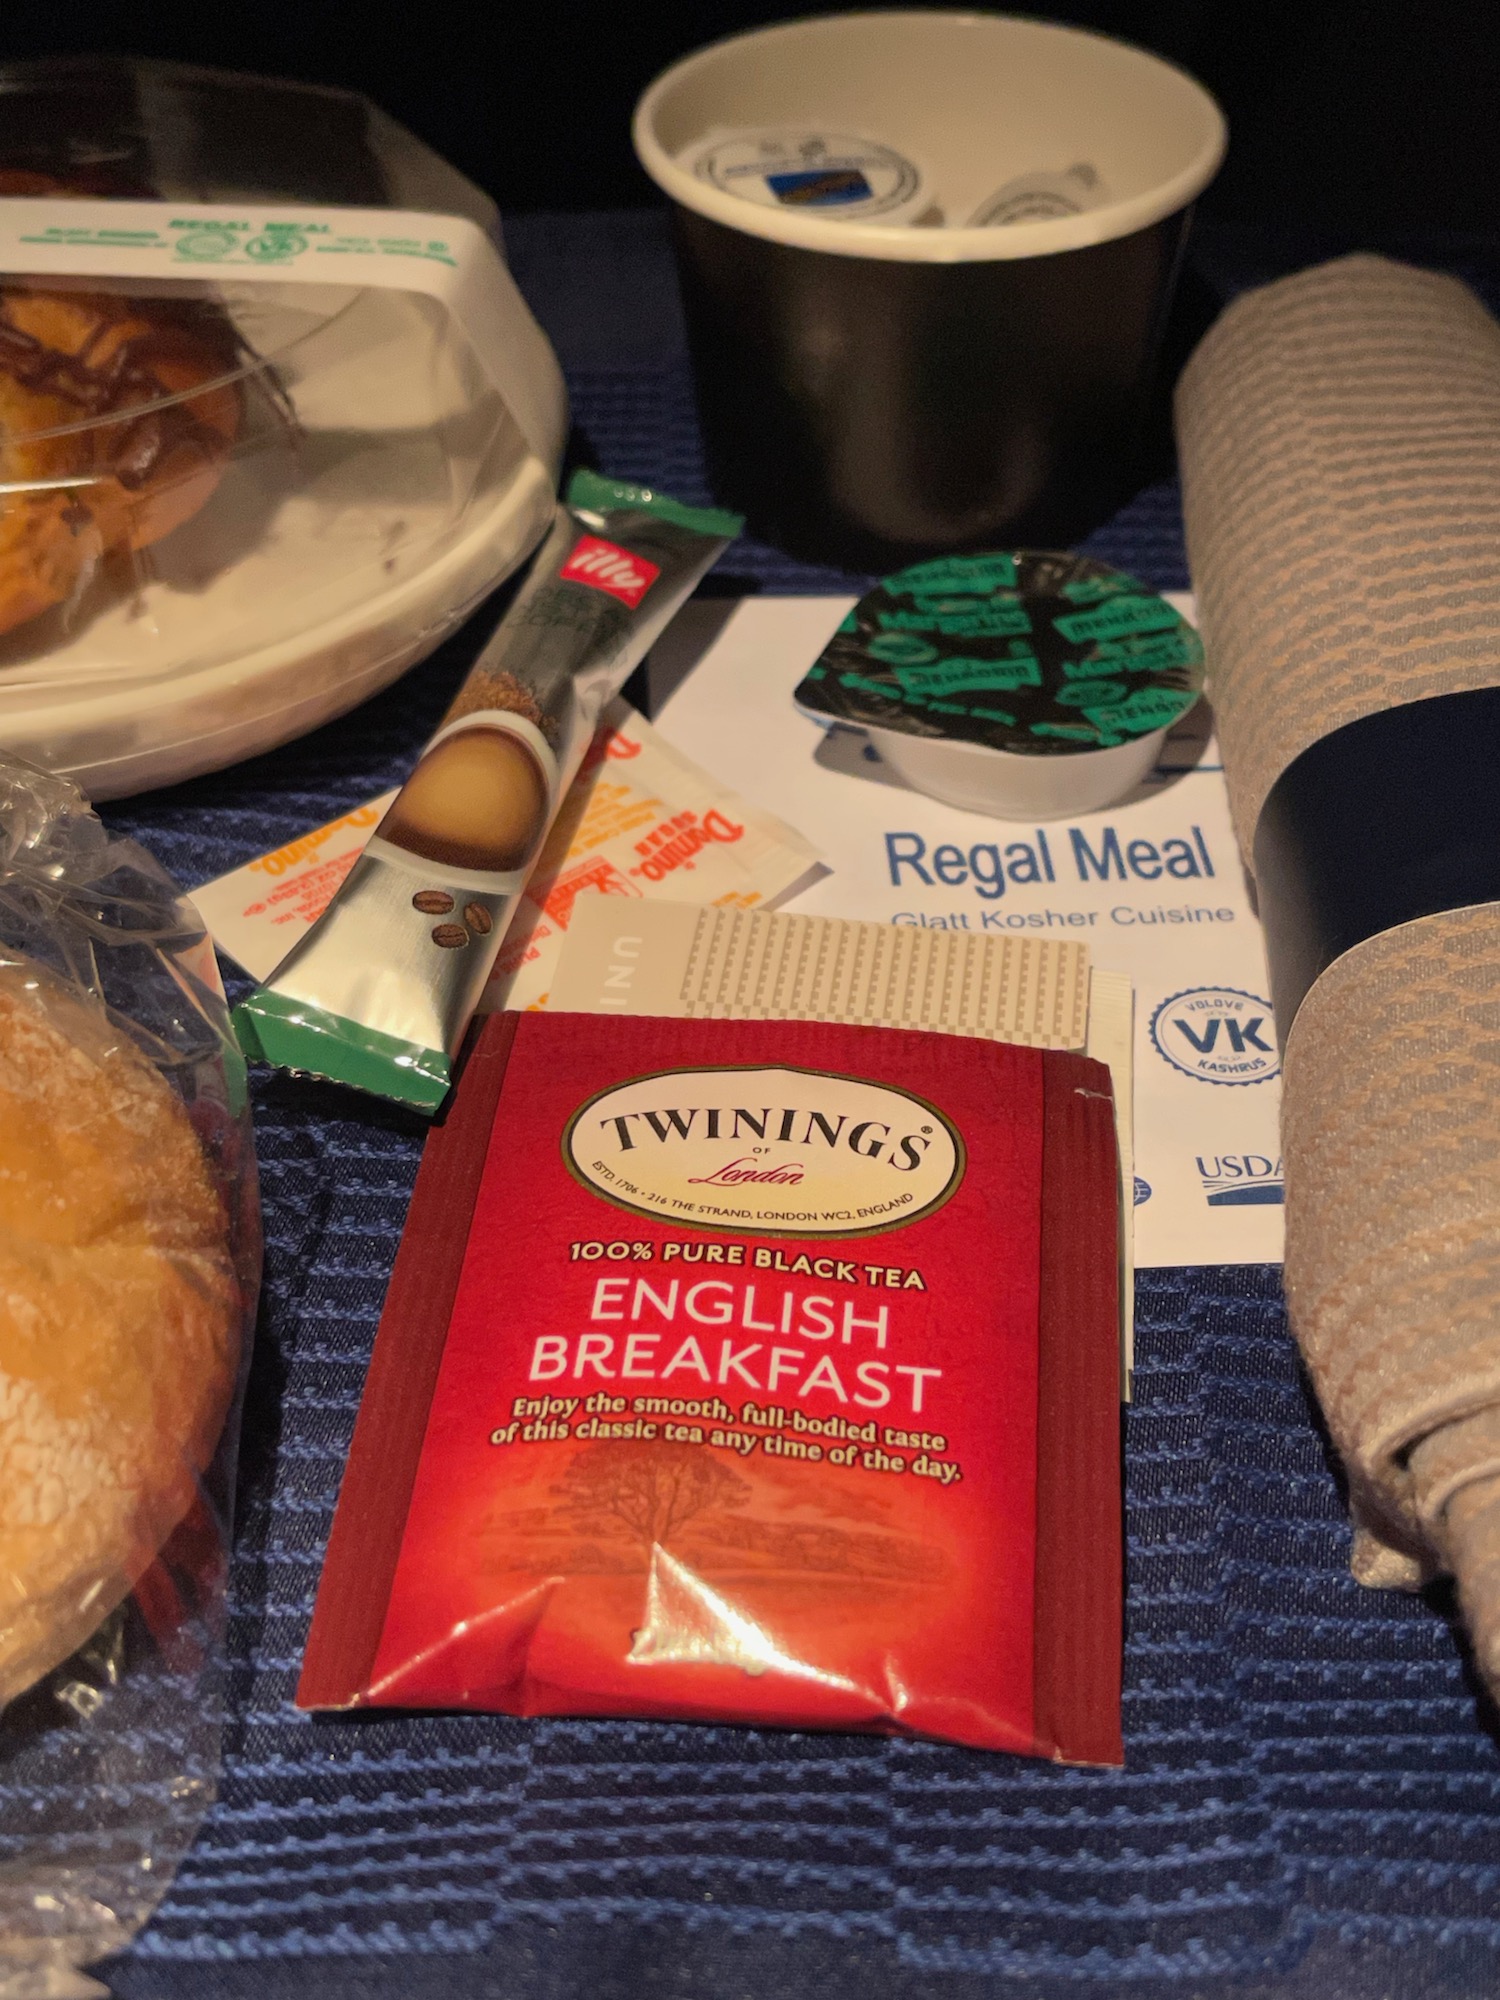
left=298, top=1014, right=1122, bottom=1764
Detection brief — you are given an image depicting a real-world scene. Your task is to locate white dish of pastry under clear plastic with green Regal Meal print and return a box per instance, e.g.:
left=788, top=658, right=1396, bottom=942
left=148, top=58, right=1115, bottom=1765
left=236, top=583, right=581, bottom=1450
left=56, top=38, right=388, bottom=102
left=0, top=60, right=566, bottom=796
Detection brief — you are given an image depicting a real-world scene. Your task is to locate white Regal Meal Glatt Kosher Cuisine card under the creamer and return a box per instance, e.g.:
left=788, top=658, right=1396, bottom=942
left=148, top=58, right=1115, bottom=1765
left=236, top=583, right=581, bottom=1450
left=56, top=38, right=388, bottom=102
left=650, top=596, right=1282, bottom=1268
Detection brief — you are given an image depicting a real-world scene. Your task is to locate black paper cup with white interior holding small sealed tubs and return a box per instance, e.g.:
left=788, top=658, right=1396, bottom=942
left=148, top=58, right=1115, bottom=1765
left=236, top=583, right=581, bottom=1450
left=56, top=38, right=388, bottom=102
left=634, top=12, right=1226, bottom=570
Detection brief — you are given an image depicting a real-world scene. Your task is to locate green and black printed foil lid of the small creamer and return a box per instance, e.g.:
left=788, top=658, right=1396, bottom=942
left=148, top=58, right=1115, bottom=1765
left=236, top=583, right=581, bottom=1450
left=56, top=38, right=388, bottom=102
left=796, top=550, right=1204, bottom=756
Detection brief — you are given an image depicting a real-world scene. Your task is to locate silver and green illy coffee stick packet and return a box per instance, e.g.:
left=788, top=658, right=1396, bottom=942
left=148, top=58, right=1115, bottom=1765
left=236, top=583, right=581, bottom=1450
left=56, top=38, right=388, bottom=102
left=234, top=472, right=740, bottom=1110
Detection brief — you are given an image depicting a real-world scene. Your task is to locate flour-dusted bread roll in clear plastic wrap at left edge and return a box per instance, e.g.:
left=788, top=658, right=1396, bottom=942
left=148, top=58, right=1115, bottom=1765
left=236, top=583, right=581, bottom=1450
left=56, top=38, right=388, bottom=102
left=0, top=754, right=260, bottom=2000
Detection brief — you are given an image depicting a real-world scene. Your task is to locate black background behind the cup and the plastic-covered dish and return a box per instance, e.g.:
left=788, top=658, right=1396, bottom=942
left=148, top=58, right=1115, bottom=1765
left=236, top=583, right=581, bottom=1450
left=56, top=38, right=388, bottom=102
left=0, top=0, right=1500, bottom=248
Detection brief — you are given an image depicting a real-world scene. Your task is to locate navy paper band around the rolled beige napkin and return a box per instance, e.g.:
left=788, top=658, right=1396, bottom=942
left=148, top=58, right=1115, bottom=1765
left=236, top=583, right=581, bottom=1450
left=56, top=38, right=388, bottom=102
left=1254, top=688, right=1500, bottom=1046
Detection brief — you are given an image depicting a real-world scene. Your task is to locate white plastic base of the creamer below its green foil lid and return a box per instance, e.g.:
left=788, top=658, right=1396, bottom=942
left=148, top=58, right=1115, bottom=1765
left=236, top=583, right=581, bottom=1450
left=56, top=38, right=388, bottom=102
left=866, top=726, right=1166, bottom=820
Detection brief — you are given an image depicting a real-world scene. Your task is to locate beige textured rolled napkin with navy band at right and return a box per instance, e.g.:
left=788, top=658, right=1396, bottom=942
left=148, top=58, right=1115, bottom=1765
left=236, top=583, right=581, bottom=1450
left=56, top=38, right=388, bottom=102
left=1176, top=256, right=1500, bottom=1690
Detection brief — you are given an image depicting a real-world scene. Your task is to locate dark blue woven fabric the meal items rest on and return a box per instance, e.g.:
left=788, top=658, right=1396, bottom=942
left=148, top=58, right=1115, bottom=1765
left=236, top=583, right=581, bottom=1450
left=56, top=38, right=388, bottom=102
left=79, top=218, right=1500, bottom=2000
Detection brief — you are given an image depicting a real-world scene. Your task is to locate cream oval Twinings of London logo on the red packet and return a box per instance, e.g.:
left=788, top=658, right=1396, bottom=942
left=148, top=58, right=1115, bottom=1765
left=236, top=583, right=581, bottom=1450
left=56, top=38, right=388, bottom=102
left=562, top=1068, right=964, bottom=1236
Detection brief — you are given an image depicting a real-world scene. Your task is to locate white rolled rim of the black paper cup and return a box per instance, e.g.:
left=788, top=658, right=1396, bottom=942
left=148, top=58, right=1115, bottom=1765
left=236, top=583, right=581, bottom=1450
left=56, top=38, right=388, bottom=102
left=630, top=8, right=1228, bottom=264
